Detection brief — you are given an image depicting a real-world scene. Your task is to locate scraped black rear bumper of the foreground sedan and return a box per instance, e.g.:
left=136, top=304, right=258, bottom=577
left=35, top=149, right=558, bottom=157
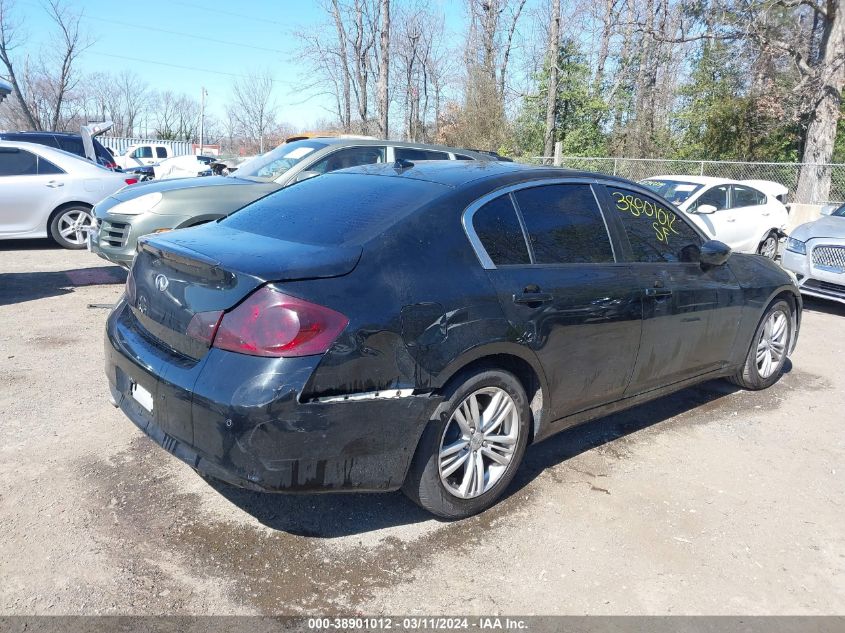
left=105, top=303, right=439, bottom=492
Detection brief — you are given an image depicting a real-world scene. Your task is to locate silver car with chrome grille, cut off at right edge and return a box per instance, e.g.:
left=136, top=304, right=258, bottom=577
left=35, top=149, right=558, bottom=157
left=782, top=204, right=845, bottom=303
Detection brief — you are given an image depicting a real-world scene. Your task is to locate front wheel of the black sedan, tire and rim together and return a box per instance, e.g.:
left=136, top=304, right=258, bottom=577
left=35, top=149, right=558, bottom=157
left=729, top=299, right=792, bottom=391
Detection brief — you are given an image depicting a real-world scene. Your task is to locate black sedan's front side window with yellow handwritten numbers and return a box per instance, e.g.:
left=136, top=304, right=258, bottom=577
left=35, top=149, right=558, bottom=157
left=607, top=186, right=706, bottom=262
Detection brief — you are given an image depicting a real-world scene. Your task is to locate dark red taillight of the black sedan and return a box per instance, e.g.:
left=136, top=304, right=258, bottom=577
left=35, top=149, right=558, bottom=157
left=187, top=286, right=349, bottom=357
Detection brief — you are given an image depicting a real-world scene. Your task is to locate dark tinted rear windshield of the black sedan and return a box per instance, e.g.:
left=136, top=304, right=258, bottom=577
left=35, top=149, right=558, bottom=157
left=221, top=173, right=450, bottom=245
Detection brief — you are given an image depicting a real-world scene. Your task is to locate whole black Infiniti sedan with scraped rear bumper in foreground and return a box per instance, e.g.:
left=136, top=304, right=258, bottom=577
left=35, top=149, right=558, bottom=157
left=106, top=161, right=801, bottom=518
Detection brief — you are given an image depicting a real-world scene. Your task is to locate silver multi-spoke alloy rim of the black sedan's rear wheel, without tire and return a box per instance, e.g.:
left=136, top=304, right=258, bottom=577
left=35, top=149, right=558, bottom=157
left=438, top=387, right=519, bottom=499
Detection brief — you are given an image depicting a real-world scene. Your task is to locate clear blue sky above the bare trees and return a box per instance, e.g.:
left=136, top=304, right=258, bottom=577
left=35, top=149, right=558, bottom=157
left=14, top=0, right=465, bottom=129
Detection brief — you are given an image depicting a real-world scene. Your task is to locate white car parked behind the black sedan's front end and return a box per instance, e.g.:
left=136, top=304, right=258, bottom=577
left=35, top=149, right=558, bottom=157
left=642, top=176, right=788, bottom=259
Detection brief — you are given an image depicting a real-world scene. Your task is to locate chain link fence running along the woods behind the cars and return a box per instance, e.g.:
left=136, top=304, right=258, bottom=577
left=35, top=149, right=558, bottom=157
left=518, top=156, right=845, bottom=204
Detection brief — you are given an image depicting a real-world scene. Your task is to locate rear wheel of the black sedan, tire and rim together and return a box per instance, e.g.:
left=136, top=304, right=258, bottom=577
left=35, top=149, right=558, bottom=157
left=402, top=369, right=531, bottom=519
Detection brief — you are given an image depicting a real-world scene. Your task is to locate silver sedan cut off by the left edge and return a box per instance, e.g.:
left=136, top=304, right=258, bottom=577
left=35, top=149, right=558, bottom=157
left=0, top=141, right=136, bottom=248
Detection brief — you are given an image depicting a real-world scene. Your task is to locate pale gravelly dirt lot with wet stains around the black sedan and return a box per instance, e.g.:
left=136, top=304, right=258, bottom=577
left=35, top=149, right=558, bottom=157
left=0, top=242, right=845, bottom=614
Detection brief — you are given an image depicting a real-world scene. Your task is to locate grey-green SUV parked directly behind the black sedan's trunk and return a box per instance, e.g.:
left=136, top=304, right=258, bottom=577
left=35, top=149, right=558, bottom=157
left=91, top=138, right=502, bottom=267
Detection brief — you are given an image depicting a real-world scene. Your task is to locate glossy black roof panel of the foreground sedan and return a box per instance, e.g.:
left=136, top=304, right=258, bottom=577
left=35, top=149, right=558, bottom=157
left=323, top=160, right=635, bottom=187
